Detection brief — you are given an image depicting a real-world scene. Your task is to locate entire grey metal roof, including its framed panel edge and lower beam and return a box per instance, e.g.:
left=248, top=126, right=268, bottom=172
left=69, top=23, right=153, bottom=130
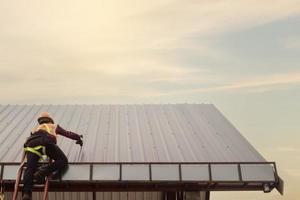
left=0, top=104, right=283, bottom=197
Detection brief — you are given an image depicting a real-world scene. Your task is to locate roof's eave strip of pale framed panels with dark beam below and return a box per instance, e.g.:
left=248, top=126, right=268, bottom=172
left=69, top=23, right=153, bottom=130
left=0, top=162, right=283, bottom=194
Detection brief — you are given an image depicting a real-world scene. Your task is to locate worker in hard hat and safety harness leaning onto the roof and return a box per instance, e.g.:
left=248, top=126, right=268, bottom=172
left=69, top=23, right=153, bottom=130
left=23, top=112, right=83, bottom=200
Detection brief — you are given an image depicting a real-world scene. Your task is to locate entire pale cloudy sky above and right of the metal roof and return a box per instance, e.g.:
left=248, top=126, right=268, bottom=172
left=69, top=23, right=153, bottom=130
left=0, top=0, right=300, bottom=200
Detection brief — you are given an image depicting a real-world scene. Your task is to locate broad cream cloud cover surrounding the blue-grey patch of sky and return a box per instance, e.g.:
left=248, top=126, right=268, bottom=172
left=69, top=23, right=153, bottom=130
left=0, top=0, right=300, bottom=102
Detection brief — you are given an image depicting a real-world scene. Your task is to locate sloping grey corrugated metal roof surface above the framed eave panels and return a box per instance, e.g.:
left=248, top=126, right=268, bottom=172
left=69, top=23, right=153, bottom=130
left=0, top=104, right=265, bottom=162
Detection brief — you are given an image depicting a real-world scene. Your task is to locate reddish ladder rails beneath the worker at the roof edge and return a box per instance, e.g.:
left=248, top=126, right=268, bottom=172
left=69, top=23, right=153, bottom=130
left=13, top=152, right=51, bottom=200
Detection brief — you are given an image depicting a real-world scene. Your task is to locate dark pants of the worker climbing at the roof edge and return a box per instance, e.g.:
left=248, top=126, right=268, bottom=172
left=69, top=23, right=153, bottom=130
left=23, top=136, right=68, bottom=194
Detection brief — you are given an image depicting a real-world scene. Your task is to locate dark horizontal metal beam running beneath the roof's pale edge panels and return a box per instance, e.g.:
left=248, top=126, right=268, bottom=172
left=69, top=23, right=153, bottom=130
left=3, top=181, right=273, bottom=192
